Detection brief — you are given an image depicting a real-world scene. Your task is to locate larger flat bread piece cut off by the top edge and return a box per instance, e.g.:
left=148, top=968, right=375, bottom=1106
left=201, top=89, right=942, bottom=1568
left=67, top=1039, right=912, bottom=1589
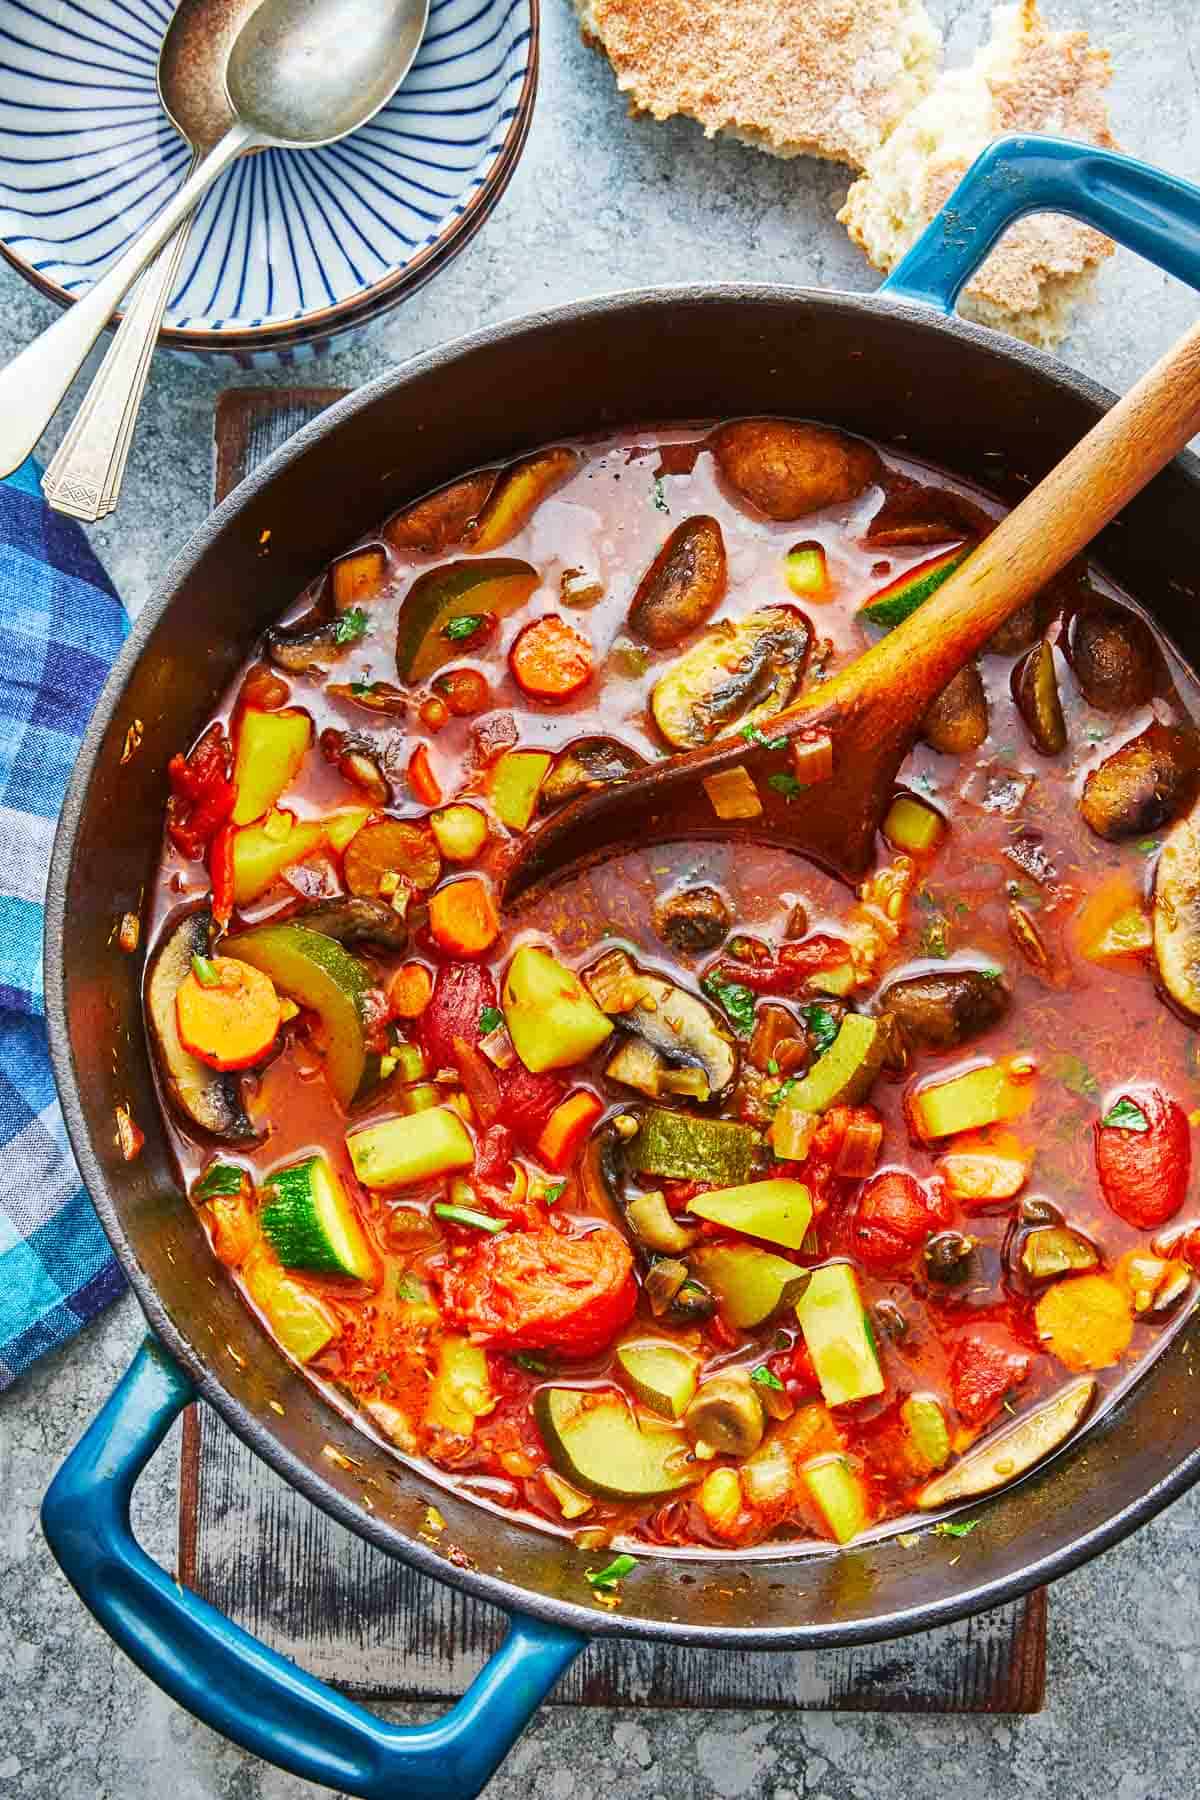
left=576, top=0, right=941, bottom=167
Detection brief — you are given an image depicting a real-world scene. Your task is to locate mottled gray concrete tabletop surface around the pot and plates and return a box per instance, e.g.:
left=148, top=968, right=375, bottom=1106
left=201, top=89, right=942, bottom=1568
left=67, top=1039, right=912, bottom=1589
left=0, top=0, right=1200, bottom=1800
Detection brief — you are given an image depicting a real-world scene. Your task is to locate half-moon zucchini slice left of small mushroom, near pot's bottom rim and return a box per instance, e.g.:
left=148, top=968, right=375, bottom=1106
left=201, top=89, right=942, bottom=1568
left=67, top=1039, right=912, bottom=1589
left=534, top=1388, right=700, bottom=1499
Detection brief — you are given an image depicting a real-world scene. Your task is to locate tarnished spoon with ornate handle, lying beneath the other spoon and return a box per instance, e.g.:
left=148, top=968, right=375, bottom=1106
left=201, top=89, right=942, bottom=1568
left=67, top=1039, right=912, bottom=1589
left=41, top=0, right=259, bottom=522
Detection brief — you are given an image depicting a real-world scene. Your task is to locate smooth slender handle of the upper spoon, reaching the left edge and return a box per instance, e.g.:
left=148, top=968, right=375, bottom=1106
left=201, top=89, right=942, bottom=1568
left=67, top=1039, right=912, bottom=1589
left=0, top=124, right=259, bottom=477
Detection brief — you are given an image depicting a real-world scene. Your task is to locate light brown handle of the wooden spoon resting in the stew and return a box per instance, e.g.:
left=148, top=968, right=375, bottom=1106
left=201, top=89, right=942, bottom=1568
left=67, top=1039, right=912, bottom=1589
left=806, top=324, right=1200, bottom=724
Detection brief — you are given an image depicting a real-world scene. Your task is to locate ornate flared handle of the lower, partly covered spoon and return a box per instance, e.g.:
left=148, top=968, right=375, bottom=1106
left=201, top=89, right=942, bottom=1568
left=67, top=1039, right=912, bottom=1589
left=41, top=158, right=200, bottom=524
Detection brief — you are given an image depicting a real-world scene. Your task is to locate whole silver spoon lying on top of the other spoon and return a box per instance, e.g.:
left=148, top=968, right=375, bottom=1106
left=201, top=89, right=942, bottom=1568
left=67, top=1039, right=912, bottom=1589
left=0, top=0, right=428, bottom=475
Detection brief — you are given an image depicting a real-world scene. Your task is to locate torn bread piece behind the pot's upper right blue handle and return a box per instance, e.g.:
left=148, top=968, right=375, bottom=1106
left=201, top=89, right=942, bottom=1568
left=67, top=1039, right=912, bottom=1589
left=838, top=0, right=1117, bottom=349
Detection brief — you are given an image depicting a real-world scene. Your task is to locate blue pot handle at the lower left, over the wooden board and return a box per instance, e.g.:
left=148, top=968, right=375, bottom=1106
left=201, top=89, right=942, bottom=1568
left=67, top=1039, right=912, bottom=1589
left=41, top=1337, right=587, bottom=1800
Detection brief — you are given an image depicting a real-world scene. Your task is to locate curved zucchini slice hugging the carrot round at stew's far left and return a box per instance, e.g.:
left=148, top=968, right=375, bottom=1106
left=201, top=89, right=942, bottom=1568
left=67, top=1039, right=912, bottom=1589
left=221, top=925, right=371, bottom=1107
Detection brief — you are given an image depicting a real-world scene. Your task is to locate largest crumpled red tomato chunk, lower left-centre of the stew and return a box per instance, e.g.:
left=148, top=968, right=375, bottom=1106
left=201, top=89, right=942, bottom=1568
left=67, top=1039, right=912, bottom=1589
left=437, top=1226, right=637, bottom=1357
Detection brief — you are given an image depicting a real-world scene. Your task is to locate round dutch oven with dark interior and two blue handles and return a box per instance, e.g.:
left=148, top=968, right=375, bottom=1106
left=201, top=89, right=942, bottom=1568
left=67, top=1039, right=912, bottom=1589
left=43, top=139, right=1200, bottom=1800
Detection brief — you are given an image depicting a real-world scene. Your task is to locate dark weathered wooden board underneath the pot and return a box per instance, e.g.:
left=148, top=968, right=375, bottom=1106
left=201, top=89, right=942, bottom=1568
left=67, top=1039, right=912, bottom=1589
left=178, top=389, right=1045, bottom=1712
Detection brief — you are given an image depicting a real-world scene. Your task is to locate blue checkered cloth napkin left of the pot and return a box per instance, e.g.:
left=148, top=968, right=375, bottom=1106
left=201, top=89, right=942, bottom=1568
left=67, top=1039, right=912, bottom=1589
left=0, top=463, right=126, bottom=1388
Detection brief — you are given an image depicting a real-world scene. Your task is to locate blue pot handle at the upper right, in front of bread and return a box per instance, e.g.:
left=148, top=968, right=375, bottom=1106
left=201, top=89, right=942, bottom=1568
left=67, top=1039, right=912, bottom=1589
left=880, top=137, right=1200, bottom=313
